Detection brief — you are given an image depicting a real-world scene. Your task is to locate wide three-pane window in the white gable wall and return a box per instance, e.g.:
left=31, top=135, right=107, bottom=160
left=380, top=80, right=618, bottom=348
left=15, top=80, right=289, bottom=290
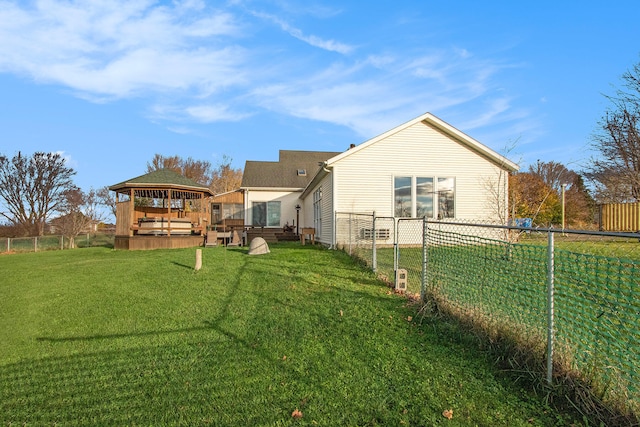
left=393, top=176, right=455, bottom=218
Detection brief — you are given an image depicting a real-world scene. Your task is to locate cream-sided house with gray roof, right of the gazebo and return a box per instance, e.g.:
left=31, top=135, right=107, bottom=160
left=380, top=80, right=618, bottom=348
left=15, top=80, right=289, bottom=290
left=242, top=113, right=518, bottom=245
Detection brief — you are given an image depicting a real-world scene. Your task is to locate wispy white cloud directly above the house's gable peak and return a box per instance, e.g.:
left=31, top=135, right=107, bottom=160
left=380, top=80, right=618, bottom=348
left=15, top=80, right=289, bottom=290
left=253, top=50, right=523, bottom=137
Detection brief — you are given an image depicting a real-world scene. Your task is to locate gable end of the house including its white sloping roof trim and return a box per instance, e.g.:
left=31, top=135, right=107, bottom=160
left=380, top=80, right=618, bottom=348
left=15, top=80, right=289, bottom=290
left=301, top=113, right=517, bottom=229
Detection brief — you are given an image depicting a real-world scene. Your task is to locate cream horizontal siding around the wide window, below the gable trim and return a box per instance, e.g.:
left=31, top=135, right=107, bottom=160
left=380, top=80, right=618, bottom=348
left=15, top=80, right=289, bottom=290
left=334, top=122, right=505, bottom=219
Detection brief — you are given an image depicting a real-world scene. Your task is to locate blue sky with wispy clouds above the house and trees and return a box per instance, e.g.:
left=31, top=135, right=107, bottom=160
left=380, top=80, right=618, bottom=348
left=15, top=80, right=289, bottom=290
left=0, top=0, right=640, bottom=190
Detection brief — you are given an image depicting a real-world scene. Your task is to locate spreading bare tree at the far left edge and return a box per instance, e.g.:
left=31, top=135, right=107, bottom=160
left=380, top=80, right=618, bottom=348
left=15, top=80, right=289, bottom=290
left=0, top=152, right=75, bottom=236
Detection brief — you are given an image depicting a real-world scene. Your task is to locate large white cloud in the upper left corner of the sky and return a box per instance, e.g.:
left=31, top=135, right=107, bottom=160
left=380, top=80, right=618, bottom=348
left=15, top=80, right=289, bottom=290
left=0, top=0, right=245, bottom=98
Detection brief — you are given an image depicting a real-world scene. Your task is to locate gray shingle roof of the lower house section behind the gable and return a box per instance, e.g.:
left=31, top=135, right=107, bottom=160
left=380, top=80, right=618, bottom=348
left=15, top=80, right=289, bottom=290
left=241, top=150, right=340, bottom=189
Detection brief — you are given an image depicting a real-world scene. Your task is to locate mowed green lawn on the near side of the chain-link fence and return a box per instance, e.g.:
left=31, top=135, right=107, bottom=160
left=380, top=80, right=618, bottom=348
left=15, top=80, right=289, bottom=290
left=0, top=244, right=572, bottom=426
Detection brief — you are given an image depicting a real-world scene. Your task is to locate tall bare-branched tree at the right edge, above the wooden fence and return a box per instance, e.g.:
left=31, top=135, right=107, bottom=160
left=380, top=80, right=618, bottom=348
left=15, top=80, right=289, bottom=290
left=585, top=58, right=640, bottom=203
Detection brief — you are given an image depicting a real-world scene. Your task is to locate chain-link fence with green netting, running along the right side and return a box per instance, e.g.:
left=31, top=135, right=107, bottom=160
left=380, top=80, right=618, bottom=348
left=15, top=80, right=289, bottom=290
left=336, top=214, right=640, bottom=415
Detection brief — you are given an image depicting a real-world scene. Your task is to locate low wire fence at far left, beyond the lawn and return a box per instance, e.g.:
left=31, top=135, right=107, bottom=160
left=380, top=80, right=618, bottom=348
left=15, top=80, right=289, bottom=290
left=0, top=233, right=114, bottom=253
